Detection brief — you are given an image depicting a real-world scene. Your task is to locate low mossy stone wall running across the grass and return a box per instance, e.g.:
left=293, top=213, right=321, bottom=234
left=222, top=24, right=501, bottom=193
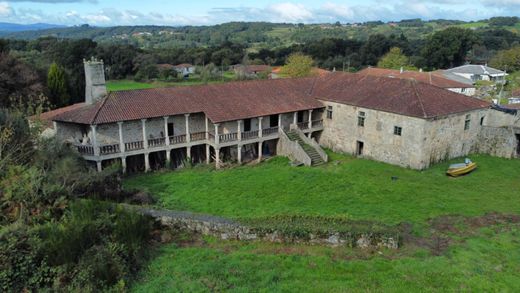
left=132, top=205, right=400, bottom=249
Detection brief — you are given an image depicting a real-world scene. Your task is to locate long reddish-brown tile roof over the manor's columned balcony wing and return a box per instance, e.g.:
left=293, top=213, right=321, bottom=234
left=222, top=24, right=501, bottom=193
left=52, top=78, right=323, bottom=124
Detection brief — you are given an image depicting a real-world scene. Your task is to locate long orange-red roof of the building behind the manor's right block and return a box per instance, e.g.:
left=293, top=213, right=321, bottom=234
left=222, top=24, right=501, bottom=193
left=357, top=67, right=474, bottom=89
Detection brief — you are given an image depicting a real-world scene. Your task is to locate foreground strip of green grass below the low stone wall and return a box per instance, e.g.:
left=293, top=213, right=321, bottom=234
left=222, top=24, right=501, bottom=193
left=131, top=227, right=520, bottom=292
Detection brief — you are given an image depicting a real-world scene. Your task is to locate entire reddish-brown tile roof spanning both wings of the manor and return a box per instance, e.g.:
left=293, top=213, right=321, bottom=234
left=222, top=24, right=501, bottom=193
left=54, top=72, right=489, bottom=124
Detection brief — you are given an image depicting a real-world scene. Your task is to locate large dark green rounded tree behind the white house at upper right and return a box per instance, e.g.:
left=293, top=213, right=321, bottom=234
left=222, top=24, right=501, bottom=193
left=422, top=27, right=477, bottom=68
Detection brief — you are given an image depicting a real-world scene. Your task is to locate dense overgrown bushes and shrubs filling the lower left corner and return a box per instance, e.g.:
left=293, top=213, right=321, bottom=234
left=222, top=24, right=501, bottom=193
left=0, top=108, right=152, bottom=292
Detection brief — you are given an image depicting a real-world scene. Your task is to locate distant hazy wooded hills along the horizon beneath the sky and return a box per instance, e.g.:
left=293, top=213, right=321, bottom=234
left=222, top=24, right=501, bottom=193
left=0, top=17, right=520, bottom=50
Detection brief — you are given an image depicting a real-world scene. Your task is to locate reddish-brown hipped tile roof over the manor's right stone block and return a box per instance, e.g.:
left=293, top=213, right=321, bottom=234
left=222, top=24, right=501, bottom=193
left=313, top=72, right=490, bottom=118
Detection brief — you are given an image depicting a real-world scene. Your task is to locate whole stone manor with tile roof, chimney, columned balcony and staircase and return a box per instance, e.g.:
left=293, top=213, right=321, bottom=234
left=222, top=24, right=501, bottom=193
left=41, top=59, right=520, bottom=172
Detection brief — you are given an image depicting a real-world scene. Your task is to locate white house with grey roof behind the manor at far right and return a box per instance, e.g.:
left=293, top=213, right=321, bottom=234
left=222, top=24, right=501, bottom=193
left=442, top=64, right=507, bottom=84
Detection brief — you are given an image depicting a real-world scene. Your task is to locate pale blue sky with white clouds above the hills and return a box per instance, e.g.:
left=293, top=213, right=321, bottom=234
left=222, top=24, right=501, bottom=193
left=0, top=0, right=520, bottom=26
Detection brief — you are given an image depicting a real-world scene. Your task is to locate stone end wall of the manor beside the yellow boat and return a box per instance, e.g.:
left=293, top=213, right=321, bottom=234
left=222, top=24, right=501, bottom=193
left=422, top=109, right=488, bottom=167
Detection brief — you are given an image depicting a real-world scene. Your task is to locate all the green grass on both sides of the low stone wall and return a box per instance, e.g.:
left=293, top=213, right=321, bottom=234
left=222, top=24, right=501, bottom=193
left=124, top=153, right=520, bottom=292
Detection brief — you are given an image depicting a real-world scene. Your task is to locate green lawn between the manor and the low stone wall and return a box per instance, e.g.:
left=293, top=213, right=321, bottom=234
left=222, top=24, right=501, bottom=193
left=124, top=153, right=520, bottom=224
